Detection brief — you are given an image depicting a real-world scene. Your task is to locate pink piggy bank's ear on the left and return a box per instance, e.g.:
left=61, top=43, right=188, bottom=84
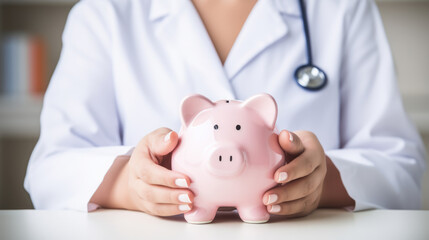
left=182, top=95, right=214, bottom=126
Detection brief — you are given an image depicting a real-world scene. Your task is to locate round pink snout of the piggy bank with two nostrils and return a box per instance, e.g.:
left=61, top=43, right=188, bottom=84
left=207, top=145, right=245, bottom=177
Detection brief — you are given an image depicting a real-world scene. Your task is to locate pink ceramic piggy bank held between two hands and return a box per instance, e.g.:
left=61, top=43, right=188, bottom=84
left=171, top=94, right=285, bottom=223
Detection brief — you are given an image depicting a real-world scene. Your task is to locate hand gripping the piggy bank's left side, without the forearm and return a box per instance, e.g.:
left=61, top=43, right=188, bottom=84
left=126, top=128, right=194, bottom=216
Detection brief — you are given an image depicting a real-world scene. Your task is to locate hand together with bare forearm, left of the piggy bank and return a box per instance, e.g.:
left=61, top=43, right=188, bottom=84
left=90, top=128, right=194, bottom=216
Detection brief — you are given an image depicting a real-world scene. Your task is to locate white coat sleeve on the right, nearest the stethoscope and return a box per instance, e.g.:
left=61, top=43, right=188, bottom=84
left=326, top=0, right=425, bottom=211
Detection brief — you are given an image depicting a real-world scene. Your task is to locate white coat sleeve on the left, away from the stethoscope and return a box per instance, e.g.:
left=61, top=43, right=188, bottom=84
left=24, top=0, right=132, bottom=211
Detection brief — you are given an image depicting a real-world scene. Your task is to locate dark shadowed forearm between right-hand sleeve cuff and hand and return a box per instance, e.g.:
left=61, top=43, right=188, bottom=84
left=319, top=156, right=355, bottom=208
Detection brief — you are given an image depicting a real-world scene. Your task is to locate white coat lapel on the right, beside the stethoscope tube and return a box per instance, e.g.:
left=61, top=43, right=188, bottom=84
left=224, top=0, right=299, bottom=79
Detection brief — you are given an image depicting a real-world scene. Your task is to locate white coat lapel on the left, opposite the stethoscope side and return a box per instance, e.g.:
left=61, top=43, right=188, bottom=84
left=149, top=0, right=235, bottom=100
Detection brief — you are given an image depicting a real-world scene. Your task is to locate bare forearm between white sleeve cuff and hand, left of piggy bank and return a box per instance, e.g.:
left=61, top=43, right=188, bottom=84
left=90, top=156, right=134, bottom=209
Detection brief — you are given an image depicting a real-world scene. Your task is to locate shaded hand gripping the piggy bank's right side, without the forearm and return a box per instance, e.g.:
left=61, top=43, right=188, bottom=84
left=263, top=130, right=327, bottom=217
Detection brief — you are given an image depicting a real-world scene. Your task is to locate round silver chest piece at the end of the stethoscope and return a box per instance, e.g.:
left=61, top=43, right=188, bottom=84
left=295, top=64, right=328, bottom=91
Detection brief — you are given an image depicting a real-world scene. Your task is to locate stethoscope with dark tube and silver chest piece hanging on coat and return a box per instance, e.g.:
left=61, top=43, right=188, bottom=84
left=294, top=0, right=328, bottom=91
